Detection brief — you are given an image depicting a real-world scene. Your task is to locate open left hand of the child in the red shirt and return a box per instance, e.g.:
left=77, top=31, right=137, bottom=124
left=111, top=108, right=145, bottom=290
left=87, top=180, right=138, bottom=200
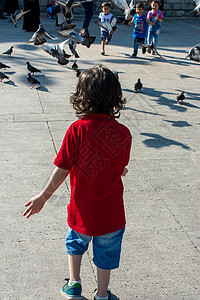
left=23, top=195, right=46, bottom=219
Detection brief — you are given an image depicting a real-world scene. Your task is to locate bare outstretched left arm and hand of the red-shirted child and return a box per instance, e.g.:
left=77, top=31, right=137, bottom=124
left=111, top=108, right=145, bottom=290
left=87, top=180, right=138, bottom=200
left=23, top=167, right=70, bottom=218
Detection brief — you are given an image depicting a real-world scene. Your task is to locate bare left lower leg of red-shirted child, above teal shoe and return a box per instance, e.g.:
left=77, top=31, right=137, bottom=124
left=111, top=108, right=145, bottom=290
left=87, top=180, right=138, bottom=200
left=68, top=254, right=82, bottom=281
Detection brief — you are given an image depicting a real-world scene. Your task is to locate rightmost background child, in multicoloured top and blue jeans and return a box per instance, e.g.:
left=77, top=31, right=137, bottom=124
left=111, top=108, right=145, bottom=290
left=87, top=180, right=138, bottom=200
left=147, top=0, right=163, bottom=54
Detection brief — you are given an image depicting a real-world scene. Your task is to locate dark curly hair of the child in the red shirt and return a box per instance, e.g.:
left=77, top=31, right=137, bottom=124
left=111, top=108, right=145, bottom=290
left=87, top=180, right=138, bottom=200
left=70, top=65, right=126, bottom=118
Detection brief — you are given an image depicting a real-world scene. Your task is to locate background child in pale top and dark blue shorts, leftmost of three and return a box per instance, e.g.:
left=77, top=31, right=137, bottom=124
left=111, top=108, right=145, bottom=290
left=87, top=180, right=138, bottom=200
left=98, top=2, right=113, bottom=55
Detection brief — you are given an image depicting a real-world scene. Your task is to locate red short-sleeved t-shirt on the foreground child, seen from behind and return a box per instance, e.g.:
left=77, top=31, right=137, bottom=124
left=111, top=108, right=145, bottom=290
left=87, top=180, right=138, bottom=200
left=54, top=114, right=131, bottom=236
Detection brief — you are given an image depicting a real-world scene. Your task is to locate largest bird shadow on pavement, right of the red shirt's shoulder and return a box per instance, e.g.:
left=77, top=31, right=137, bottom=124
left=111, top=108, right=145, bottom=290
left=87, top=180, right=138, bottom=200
left=140, top=133, right=190, bottom=150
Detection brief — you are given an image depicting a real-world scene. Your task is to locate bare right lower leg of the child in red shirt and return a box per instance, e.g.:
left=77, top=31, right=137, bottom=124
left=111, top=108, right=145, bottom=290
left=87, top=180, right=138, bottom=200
left=97, top=268, right=111, bottom=298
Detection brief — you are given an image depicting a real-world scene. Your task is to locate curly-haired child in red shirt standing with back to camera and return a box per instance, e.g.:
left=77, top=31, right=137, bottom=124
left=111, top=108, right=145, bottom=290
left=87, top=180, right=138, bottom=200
left=23, top=65, right=131, bottom=300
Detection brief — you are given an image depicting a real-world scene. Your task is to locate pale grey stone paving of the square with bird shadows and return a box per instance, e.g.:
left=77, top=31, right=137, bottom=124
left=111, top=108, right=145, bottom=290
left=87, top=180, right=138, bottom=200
left=0, top=17, right=200, bottom=300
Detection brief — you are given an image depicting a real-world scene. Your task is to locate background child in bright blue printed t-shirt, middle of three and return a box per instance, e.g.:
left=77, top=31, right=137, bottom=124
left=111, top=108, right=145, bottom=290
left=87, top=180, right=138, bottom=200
left=129, top=2, right=148, bottom=58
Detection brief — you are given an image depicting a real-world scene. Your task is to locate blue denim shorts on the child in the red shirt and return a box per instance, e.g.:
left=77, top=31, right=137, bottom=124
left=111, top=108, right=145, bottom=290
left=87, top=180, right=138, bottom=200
left=66, top=227, right=125, bottom=270
